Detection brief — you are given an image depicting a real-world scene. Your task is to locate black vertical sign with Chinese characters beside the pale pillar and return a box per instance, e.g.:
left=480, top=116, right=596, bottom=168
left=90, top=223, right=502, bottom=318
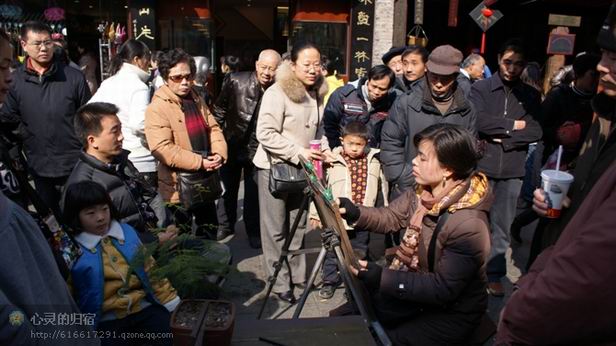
left=349, top=0, right=374, bottom=80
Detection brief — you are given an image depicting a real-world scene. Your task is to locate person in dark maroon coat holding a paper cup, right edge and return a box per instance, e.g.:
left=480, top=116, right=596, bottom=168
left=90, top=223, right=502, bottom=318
left=495, top=5, right=616, bottom=345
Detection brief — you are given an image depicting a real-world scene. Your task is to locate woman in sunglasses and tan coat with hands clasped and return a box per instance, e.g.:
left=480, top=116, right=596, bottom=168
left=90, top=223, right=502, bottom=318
left=145, top=49, right=227, bottom=239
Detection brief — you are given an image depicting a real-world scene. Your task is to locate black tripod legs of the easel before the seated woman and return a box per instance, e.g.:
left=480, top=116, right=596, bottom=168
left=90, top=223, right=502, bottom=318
left=257, top=187, right=391, bottom=346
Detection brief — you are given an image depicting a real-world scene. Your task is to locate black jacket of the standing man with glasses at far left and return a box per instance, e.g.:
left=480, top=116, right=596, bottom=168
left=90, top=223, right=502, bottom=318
left=0, top=57, right=90, bottom=177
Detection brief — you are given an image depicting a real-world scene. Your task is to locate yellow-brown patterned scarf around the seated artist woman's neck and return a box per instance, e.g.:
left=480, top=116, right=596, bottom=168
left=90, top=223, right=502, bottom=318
left=389, top=173, right=489, bottom=271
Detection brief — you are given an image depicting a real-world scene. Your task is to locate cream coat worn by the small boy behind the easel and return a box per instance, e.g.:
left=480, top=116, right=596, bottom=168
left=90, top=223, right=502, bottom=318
left=310, top=147, right=389, bottom=229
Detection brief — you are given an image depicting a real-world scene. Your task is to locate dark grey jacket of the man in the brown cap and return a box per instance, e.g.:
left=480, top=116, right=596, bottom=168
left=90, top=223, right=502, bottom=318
left=381, top=80, right=477, bottom=195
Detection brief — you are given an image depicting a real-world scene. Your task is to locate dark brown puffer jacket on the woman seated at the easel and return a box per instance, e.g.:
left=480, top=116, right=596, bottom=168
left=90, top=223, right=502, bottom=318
left=355, top=174, right=493, bottom=345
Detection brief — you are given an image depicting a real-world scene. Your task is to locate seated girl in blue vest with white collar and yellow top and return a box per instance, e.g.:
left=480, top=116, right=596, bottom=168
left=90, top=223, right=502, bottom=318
left=65, top=181, right=180, bottom=345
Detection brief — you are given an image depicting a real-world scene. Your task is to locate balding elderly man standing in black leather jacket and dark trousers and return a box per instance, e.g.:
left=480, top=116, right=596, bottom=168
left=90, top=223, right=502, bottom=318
left=214, top=49, right=281, bottom=248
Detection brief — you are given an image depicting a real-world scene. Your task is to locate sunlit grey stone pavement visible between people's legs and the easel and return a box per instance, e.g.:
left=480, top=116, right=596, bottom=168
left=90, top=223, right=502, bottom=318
left=217, top=195, right=534, bottom=344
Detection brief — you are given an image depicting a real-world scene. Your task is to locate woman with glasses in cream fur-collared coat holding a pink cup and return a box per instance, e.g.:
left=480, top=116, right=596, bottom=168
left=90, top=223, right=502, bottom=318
left=253, top=44, right=329, bottom=302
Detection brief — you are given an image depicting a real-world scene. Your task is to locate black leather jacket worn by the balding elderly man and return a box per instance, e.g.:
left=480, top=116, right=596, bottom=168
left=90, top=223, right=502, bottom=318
left=213, top=72, right=264, bottom=162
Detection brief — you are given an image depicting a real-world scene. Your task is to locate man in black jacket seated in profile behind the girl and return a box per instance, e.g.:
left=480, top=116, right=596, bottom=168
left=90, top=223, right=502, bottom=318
left=61, top=102, right=171, bottom=243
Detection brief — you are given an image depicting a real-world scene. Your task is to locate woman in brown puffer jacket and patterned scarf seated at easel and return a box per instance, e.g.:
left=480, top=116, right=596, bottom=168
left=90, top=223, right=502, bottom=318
left=340, top=124, right=492, bottom=345
